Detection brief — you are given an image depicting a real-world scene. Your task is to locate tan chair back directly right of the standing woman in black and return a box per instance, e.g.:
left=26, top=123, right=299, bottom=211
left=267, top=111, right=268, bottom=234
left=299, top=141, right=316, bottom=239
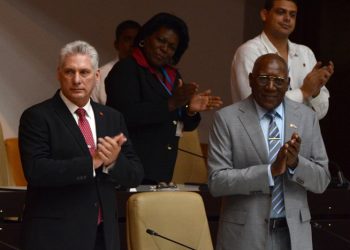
left=172, top=129, right=208, bottom=184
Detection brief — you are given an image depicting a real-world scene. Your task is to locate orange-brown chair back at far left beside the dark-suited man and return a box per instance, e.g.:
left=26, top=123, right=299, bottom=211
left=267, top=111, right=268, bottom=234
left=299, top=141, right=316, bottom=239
left=5, top=138, right=27, bottom=186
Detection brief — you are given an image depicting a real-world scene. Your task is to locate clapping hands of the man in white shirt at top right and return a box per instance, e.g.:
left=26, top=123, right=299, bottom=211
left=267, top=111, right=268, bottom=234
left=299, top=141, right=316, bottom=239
left=300, top=61, right=334, bottom=99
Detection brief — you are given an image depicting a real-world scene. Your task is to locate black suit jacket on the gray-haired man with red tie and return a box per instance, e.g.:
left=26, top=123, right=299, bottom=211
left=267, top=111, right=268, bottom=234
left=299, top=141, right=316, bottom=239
left=19, top=92, right=143, bottom=250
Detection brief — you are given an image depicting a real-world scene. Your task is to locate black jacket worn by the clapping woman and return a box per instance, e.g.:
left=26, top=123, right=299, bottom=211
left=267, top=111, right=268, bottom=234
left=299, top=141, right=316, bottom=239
left=105, top=57, right=200, bottom=182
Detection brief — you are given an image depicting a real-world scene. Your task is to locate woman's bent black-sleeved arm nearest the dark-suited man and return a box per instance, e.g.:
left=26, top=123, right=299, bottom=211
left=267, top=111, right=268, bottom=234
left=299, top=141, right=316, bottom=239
left=105, top=59, right=183, bottom=127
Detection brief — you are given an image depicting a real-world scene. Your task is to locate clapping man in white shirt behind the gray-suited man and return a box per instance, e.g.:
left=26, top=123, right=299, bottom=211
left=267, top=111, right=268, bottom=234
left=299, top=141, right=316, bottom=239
left=231, top=0, right=334, bottom=119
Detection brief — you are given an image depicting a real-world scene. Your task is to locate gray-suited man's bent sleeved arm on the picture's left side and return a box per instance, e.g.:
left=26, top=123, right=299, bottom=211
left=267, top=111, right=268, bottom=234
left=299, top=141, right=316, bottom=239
left=208, top=112, right=270, bottom=196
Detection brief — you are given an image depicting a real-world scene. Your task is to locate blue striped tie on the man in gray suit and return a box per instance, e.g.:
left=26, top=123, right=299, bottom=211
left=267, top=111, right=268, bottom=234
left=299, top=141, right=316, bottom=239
left=266, top=112, right=285, bottom=218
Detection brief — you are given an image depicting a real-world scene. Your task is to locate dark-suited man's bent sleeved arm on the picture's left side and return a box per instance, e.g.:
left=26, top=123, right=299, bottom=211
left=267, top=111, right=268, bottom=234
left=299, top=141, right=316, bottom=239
left=19, top=108, right=94, bottom=187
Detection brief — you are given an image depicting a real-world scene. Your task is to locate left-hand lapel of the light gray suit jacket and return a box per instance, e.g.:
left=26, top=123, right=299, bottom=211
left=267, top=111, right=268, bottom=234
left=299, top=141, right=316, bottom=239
left=239, top=96, right=268, bottom=163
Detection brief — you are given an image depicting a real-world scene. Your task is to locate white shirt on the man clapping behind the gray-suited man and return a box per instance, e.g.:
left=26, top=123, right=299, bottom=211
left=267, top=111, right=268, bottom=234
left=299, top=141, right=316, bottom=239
left=231, top=32, right=329, bottom=119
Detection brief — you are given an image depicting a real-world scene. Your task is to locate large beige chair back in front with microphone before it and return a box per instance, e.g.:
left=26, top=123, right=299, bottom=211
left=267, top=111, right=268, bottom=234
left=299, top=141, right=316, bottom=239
left=126, top=191, right=213, bottom=250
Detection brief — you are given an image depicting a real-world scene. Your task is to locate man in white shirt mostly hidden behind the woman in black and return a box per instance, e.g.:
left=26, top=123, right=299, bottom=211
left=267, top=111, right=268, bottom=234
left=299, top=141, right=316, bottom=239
left=91, top=20, right=141, bottom=104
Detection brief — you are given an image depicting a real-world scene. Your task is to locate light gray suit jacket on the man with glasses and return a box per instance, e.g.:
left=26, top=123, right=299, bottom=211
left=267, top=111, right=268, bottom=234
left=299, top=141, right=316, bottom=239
left=208, top=96, right=330, bottom=250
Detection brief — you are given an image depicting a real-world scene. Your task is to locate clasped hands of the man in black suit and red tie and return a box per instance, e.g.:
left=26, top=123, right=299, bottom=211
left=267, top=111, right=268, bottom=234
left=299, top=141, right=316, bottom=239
left=93, top=133, right=127, bottom=169
